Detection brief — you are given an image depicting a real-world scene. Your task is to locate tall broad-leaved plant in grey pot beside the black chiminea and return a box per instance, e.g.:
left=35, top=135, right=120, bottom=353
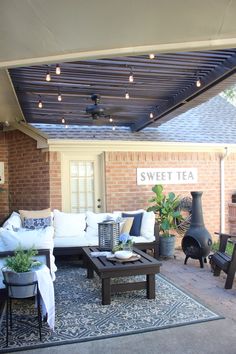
left=147, top=184, right=183, bottom=257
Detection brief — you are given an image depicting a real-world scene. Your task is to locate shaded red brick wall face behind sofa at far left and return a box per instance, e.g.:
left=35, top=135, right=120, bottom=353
left=7, top=130, right=50, bottom=211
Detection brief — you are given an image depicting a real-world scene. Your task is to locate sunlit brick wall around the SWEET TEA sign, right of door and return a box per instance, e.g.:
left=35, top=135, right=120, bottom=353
left=106, top=152, right=225, bottom=239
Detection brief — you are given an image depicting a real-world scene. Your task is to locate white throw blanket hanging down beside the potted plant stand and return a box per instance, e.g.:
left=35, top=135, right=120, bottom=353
left=35, top=265, right=55, bottom=330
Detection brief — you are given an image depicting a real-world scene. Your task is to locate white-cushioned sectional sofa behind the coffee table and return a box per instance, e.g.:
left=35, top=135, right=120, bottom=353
left=0, top=209, right=159, bottom=258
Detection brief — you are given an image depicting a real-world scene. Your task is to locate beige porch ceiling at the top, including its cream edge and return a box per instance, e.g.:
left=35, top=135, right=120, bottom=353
left=0, top=0, right=236, bottom=121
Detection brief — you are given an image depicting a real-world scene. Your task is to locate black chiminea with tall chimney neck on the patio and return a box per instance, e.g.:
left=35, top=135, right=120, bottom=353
left=182, top=192, right=212, bottom=268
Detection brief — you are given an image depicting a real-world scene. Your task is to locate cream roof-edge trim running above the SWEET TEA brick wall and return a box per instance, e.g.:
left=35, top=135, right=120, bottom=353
left=48, top=139, right=236, bottom=153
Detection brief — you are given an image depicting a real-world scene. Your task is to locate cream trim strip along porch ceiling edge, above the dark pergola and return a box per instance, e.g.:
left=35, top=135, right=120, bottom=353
left=0, top=37, right=236, bottom=68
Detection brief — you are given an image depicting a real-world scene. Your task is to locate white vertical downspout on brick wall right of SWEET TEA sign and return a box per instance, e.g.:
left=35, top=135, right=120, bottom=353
left=220, top=146, right=229, bottom=233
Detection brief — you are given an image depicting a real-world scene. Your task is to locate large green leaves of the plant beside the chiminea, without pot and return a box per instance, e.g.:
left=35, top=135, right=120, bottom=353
left=147, top=184, right=183, bottom=237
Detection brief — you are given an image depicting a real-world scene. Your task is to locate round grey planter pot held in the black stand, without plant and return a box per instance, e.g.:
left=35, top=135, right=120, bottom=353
left=2, top=268, right=37, bottom=299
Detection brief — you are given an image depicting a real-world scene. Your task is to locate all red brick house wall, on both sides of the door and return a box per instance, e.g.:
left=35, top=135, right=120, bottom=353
left=0, top=131, right=236, bottom=241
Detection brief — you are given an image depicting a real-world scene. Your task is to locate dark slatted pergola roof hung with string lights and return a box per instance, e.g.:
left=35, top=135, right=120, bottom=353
left=9, top=49, right=236, bottom=130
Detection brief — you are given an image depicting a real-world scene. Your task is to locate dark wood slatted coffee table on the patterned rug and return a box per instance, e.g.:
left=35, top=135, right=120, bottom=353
left=82, top=247, right=161, bottom=305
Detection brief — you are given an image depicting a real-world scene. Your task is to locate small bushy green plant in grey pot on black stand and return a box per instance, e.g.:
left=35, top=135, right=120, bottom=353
left=2, top=248, right=42, bottom=298
